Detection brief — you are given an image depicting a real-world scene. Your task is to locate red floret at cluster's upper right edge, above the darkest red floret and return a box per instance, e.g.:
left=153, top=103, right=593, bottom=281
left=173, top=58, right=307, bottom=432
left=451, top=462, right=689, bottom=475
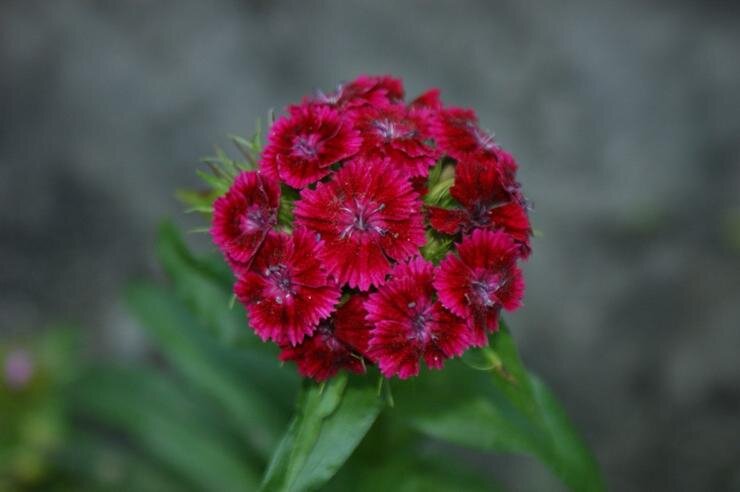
left=431, top=108, right=499, bottom=160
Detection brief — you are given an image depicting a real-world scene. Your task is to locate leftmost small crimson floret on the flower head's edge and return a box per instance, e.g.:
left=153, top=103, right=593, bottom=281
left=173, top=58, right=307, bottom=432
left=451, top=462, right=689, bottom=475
left=211, top=172, right=280, bottom=265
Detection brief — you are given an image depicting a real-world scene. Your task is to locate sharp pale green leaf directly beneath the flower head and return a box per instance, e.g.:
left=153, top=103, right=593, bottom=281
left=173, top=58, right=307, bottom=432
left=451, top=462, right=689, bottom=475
left=260, top=373, right=383, bottom=492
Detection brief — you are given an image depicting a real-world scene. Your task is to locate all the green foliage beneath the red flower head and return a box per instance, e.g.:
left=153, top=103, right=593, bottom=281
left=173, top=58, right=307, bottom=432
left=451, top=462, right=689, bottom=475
left=33, top=223, right=603, bottom=492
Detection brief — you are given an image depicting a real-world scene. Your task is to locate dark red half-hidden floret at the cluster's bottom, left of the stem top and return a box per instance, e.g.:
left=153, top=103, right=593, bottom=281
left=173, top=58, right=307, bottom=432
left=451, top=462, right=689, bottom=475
left=280, top=295, right=371, bottom=381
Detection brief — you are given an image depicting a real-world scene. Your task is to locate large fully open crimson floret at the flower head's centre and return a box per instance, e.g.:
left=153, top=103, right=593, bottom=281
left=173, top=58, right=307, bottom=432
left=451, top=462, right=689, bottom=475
left=293, top=159, right=426, bottom=291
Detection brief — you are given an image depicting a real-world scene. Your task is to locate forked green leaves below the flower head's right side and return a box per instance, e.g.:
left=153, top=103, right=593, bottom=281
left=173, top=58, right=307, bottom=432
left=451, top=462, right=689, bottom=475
left=396, top=321, right=604, bottom=491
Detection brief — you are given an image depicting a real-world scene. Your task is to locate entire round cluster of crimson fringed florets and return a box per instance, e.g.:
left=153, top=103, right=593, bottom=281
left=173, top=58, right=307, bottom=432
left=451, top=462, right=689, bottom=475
left=211, top=76, right=531, bottom=381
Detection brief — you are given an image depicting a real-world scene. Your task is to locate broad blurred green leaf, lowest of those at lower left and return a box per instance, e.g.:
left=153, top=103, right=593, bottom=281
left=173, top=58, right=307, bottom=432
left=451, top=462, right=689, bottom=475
left=71, top=367, right=257, bottom=490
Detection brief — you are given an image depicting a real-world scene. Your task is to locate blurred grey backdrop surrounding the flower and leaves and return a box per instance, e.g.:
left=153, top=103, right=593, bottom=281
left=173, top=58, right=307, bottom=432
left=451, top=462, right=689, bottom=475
left=0, top=0, right=740, bottom=491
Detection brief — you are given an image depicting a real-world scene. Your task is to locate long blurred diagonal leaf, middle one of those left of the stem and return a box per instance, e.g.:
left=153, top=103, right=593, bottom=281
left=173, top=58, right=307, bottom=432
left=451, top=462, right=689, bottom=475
left=128, top=284, right=292, bottom=456
